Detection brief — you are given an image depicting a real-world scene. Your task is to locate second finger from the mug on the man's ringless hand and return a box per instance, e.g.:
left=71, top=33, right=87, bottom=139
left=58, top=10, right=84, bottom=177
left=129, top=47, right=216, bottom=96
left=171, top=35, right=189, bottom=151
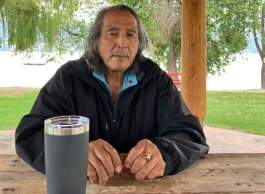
left=94, top=146, right=114, bottom=177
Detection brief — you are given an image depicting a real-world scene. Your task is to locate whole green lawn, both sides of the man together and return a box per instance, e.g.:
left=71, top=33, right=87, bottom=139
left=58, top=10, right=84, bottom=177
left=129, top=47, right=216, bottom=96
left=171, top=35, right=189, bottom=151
left=0, top=91, right=265, bottom=135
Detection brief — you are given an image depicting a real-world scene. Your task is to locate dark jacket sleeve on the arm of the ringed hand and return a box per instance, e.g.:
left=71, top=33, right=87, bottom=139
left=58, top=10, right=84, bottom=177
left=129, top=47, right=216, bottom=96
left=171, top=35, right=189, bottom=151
left=152, top=72, right=209, bottom=175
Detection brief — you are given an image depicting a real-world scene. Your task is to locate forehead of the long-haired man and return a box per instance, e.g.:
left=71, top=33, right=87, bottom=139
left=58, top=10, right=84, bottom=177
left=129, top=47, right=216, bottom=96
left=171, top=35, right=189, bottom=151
left=103, top=10, right=137, bottom=30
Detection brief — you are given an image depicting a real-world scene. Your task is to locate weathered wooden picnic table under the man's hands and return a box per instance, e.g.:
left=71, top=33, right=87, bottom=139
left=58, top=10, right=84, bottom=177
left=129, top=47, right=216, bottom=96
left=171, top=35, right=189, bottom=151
left=0, top=153, right=265, bottom=194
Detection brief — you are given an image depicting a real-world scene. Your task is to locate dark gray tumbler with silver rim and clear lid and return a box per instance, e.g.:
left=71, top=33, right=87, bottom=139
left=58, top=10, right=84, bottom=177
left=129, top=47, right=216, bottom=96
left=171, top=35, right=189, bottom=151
left=44, top=115, right=89, bottom=194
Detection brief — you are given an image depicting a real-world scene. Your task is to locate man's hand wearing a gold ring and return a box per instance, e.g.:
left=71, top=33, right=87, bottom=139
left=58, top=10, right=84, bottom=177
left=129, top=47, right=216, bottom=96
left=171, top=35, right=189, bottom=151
left=125, top=139, right=166, bottom=180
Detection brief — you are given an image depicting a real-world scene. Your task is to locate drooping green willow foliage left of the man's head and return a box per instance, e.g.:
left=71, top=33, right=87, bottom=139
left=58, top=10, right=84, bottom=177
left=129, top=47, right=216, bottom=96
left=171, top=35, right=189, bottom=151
left=0, top=0, right=87, bottom=53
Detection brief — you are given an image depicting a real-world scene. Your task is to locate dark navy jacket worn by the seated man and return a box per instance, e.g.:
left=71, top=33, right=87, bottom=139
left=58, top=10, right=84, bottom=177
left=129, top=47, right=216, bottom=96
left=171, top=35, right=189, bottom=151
left=15, top=58, right=208, bottom=175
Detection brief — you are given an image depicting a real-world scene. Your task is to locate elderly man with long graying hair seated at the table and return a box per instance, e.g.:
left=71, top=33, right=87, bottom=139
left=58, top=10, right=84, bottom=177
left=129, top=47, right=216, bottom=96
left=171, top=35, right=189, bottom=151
left=16, top=5, right=208, bottom=184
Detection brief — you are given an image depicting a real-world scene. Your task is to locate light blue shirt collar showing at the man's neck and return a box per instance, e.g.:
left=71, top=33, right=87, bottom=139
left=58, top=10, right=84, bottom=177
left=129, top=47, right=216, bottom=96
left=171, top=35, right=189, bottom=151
left=92, top=70, right=138, bottom=94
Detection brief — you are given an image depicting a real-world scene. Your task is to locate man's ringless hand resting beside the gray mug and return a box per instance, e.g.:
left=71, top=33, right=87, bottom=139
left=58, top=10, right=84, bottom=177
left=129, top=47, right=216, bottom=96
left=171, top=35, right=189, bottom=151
left=87, top=139, right=122, bottom=184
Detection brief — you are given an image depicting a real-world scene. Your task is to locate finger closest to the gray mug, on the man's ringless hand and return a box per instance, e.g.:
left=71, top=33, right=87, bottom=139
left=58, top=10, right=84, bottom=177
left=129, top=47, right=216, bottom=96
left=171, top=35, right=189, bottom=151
left=89, top=149, right=109, bottom=184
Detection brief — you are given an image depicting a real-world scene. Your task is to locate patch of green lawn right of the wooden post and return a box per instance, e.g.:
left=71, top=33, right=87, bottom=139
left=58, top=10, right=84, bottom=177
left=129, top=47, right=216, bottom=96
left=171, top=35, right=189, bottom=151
left=205, top=92, right=265, bottom=135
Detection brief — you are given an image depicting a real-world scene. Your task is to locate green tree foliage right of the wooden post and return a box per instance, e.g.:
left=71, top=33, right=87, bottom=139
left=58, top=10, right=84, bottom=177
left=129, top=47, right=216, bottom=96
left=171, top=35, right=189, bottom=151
left=207, top=0, right=261, bottom=74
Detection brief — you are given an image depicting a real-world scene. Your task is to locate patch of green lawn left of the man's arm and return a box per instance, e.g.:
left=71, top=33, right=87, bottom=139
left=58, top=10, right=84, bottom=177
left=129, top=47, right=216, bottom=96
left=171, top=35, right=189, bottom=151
left=0, top=91, right=38, bottom=131
